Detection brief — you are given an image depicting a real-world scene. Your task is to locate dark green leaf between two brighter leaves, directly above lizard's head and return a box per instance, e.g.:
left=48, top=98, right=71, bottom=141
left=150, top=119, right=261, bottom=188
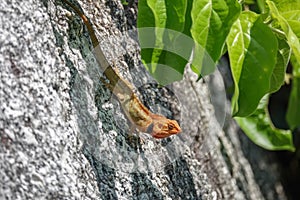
left=153, top=0, right=194, bottom=85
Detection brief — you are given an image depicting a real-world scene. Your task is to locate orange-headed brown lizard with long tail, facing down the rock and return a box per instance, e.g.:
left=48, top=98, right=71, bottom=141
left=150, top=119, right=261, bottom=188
left=62, top=0, right=181, bottom=139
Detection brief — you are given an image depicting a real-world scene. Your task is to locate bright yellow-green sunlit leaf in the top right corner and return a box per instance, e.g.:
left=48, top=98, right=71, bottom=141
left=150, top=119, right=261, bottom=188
left=267, top=0, right=300, bottom=76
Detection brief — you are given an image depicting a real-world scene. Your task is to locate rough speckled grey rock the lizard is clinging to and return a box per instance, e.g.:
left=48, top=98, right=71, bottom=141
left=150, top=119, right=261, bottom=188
left=0, top=0, right=285, bottom=199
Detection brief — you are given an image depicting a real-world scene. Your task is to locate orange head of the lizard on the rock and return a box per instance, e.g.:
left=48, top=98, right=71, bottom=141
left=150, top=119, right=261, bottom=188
left=147, top=115, right=181, bottom=139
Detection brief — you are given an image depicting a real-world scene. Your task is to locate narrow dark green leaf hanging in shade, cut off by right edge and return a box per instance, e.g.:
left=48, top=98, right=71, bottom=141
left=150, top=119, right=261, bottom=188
left=286, top=55, right=300, bottom=130
